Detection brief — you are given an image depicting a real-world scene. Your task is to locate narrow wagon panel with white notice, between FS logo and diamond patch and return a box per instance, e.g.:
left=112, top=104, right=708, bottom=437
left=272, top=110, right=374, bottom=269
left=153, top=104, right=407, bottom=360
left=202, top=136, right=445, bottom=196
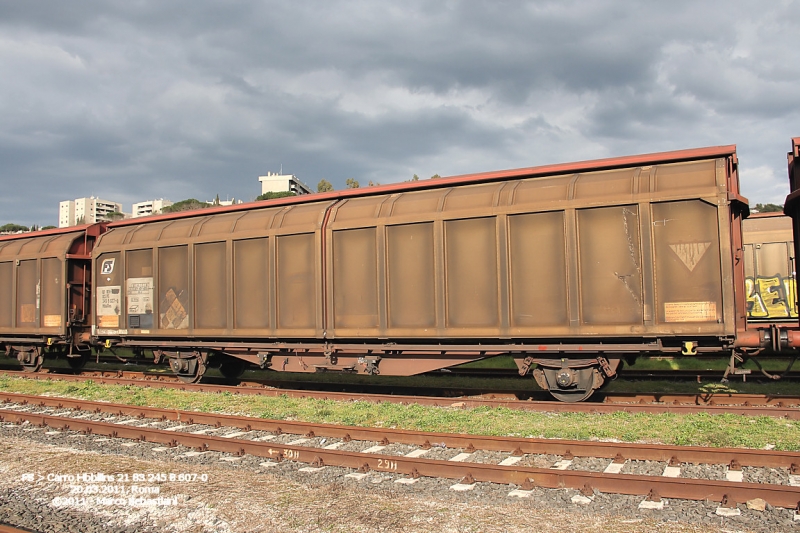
left=125, top=249, right=155, bottom=332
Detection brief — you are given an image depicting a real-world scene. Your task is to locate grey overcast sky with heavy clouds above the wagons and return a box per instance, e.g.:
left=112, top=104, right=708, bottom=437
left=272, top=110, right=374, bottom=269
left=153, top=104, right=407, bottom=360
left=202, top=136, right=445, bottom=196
left=0, top=0, right=800, bottom=225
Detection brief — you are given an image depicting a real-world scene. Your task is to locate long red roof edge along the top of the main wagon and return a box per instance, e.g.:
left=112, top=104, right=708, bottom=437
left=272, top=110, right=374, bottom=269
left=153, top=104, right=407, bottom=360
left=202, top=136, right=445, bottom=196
left=108, top=144, right=736, bottom=229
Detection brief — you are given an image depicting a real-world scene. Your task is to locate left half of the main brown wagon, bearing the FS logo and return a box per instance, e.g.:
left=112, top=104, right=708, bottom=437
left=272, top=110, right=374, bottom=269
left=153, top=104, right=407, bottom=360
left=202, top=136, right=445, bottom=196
left=94, top=201, right=332, bottom=380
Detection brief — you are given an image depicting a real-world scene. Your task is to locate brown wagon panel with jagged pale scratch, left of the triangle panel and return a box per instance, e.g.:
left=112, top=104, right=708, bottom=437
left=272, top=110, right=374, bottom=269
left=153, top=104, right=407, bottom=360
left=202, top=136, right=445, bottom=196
left=578, top=205, right=644, bottom=325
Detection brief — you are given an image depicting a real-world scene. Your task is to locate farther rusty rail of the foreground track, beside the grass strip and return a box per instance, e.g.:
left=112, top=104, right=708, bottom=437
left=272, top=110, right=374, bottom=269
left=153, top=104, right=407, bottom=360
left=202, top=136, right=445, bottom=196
left=0, top=392, right=800, bottom=468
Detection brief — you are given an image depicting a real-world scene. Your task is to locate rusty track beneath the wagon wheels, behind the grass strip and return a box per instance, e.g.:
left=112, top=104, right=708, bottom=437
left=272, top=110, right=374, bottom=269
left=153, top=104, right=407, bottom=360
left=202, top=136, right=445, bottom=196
left=0, top=371, right=800, bottom=420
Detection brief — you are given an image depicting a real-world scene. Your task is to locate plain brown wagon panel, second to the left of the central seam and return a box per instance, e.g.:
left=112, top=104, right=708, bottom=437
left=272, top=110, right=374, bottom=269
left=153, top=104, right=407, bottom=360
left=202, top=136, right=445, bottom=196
left=233, top=238, right=271, bottom=330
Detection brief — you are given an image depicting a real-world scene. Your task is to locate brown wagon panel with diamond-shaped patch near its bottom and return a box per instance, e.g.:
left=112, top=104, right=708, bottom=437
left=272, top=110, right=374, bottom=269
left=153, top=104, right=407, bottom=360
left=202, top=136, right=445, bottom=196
left=158, top=245, right=190, bottom=329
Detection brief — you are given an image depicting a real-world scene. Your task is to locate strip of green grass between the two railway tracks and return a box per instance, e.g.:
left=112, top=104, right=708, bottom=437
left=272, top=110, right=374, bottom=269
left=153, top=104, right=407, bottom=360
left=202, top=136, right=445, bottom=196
left=0, top=377, right=800, bottom=451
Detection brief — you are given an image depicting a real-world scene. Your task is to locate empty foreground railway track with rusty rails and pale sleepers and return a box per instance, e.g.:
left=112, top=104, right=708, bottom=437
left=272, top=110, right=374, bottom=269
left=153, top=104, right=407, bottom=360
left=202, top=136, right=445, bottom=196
left=0, top=393, right=800, bottom=515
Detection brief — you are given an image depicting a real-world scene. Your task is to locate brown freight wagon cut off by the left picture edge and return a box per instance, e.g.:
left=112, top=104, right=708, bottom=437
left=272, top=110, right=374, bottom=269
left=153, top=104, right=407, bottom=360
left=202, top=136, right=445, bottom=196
left=0, top=224, right=105, bottom=372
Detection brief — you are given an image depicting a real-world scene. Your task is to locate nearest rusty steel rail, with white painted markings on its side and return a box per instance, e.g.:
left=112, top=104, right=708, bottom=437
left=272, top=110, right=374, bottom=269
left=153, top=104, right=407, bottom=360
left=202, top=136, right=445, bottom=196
left=0, top=410, right=800, bottom=508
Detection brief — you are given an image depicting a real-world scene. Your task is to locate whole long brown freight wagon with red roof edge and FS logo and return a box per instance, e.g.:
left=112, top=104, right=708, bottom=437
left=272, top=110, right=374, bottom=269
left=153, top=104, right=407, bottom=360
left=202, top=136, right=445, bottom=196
left=93, top=146, right=794, bottom=401
